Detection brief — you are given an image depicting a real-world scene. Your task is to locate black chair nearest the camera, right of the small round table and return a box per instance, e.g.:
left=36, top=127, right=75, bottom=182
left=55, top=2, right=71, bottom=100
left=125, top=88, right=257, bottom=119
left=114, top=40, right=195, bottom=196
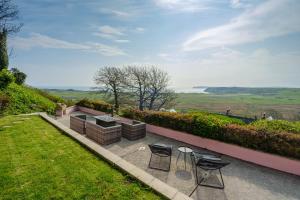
left=190, top=152, right=230, bottom=196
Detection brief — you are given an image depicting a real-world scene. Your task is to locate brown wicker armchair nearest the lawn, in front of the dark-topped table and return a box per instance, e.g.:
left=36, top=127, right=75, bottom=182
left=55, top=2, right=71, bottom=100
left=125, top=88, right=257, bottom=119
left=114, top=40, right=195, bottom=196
left=86, top=122, right=122, bottom=145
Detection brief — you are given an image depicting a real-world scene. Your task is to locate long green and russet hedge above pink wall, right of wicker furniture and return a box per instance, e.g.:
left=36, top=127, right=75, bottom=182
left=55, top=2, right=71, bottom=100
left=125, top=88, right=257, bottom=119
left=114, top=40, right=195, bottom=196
left=122, top=109, right=300, bottom=159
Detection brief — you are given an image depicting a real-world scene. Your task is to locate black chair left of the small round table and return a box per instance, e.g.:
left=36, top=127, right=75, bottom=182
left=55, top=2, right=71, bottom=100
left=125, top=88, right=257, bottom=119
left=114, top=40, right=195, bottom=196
left=148, top=143, right=172, bottom=171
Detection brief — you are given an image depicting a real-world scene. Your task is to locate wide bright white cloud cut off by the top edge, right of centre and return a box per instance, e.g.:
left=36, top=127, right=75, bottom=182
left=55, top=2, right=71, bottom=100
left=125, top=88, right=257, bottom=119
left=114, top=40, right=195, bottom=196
left=154, top=0, right=207, bottom=12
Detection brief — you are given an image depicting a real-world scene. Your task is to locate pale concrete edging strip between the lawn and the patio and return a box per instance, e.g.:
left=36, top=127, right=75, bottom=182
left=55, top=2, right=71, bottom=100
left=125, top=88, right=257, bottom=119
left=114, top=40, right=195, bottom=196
left=37, top=113, right=192, bottom=200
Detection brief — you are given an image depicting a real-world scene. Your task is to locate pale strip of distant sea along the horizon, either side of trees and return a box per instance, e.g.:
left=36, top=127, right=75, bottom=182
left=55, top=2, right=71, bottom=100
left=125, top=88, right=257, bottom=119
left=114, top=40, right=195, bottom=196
left=38, top=86, right=208, bottom=94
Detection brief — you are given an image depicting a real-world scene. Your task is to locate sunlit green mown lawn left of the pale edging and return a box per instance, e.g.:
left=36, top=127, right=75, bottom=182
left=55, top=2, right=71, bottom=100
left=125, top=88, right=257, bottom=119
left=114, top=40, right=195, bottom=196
left=0, top=116, right=162, bottom=200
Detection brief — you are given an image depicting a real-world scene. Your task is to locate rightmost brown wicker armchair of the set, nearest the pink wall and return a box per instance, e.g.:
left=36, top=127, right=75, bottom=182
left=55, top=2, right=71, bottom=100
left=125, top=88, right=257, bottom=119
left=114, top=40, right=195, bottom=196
left=122, top=120, right=146, bottom=140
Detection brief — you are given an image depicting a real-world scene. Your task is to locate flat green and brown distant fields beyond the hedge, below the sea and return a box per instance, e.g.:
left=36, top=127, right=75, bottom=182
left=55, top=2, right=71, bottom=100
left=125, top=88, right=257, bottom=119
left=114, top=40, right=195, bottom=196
left=46, top=88, right=300, bottom=120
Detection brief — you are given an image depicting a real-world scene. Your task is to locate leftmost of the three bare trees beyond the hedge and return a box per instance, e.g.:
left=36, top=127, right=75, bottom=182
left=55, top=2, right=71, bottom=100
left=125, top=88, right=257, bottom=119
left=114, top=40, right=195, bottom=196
left=94, top=67, right=124, bottom=113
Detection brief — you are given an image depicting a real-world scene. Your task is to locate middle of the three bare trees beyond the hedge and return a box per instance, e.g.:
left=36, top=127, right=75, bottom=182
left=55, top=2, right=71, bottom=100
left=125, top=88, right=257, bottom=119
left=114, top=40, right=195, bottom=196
left=125, top=66, right=149, bottom=110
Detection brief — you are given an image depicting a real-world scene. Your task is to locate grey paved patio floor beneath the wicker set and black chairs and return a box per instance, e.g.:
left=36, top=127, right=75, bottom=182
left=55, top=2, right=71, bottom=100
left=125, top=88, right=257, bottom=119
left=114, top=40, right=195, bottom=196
left=57, top=112, right=300, bottom=200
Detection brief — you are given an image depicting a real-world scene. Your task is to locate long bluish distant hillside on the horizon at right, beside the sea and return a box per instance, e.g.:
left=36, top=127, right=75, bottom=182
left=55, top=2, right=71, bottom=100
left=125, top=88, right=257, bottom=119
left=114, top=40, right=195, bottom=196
left=199, top=87, right=300, bottom=95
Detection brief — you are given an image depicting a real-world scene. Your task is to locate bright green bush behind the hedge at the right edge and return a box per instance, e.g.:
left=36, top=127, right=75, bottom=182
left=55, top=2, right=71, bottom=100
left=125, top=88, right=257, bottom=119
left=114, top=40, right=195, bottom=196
left=252, top=120, right=300, bottom=134
